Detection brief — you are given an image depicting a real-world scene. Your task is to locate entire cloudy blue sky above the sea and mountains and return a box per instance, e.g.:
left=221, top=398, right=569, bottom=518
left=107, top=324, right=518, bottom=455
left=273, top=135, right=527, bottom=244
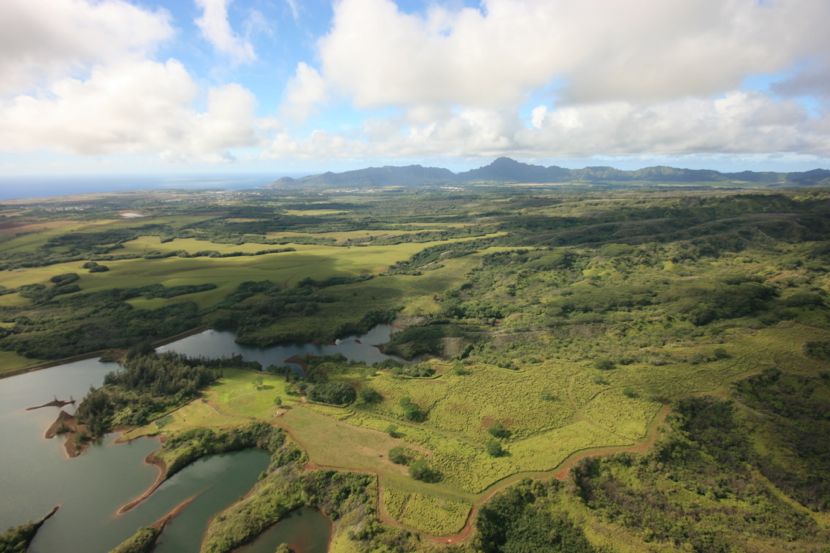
left=0, top=0, right=830, bottom=177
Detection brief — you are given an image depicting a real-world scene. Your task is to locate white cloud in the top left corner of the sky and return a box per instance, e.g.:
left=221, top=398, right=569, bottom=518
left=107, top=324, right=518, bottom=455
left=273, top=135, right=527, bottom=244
left=0, top=0, right=173, bottom=94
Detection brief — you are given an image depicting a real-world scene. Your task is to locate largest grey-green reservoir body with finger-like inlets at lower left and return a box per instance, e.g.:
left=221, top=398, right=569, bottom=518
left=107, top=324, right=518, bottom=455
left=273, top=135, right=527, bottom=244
left=0, top=359, right=268, bottom=553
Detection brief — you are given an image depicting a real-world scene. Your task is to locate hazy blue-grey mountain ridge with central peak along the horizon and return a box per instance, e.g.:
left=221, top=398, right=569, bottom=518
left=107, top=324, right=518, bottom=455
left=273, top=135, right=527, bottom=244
left=271, top=157, right=830, bottom=188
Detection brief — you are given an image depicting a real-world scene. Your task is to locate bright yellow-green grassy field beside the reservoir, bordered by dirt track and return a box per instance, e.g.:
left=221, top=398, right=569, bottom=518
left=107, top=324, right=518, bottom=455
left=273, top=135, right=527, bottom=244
left=122, top=314, right=826, bottom=535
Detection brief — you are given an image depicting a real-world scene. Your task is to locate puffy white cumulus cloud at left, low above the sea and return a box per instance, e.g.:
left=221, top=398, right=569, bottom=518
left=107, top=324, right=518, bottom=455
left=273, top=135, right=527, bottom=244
left=0, top=60, right=257, bottom=161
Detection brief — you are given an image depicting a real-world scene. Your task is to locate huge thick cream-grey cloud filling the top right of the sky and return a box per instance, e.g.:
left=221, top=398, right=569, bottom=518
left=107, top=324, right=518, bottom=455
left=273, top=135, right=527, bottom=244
left=319, top=0, right=830, bottom=108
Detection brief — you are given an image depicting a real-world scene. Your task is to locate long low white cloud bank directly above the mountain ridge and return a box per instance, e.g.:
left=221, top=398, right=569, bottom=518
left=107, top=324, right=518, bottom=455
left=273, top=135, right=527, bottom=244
left=267, top=91, right=830, bottom=158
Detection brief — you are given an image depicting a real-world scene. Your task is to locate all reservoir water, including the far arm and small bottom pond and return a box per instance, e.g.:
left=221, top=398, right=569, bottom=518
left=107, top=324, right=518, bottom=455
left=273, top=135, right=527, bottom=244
left=0, top=325, right=391, bottom=553
